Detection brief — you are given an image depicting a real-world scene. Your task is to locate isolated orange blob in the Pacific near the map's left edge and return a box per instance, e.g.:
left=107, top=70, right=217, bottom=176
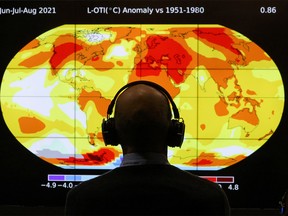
left=18, top=117, right=45, bottom=133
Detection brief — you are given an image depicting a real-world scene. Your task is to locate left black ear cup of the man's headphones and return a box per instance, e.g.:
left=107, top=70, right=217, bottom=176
left=102, top=118, right=119, bottom=146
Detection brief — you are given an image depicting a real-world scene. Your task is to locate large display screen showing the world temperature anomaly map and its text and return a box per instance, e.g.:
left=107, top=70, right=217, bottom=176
left=0, top=0, right=288, bottom=208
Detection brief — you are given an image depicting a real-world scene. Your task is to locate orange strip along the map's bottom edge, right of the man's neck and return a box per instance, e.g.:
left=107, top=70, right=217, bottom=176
left=185, top=152, right=246, bottom=167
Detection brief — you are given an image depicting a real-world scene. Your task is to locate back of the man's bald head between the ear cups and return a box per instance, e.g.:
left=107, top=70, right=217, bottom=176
left=114, top=84, right=172, bottom=154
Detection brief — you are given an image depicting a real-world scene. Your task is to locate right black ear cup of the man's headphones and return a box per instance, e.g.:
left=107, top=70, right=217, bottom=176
left=168, top=119, right=185, bottom=147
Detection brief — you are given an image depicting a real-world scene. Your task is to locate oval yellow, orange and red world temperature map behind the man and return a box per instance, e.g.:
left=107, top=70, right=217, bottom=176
left=1, top=24, right=284, bottom=170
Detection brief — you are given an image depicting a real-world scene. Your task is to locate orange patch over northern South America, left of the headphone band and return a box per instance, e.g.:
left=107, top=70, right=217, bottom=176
left=78, top=89, right=111, bottom=116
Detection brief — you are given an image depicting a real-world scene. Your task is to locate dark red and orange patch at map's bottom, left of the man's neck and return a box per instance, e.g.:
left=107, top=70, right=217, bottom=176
left=53, top=148, right=120, bottom=166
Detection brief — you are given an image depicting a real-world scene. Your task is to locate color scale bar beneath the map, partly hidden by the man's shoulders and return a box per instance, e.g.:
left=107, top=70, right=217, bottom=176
left=48, top=174, right=234, bottom=184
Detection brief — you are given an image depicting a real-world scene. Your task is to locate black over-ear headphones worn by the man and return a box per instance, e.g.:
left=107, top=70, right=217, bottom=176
left=102, top=80, right=185, bottom=147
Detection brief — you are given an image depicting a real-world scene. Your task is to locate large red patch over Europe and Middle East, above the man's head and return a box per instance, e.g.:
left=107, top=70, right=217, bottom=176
left=136, top=35, right=192, bottom=84
